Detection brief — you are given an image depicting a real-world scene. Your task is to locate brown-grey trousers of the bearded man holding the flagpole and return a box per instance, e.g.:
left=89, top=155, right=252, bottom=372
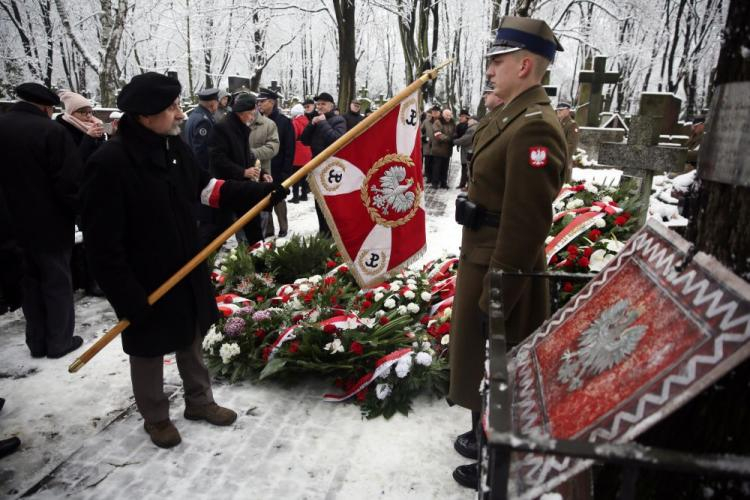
left=130, top=332, right=214, bottom=423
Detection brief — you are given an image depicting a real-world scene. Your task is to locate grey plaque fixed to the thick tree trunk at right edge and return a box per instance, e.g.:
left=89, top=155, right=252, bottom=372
left=698, top=81, right=750, bottom=187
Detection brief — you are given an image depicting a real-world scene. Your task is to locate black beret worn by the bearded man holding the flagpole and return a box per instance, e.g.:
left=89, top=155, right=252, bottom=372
left=117, top=72, right=182, bottom=115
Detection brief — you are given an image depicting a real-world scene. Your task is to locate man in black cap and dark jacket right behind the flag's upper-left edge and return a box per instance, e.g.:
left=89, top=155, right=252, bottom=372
left=300, top=92, right=346, bottom=236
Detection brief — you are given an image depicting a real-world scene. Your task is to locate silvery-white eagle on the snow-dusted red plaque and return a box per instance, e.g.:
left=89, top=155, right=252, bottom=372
left=557, top=299, right=647, bottom=391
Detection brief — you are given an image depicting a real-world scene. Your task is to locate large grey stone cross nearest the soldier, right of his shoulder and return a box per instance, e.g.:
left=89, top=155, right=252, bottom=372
left=598, top=93, right=687, bottom=226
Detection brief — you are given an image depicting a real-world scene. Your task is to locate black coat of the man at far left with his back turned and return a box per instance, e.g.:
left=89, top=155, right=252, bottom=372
left=0, top=102, right=83, bottom=252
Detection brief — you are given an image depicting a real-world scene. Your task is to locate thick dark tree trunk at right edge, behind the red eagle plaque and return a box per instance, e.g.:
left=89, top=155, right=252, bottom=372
left=597, top=0, right=750, bottom=500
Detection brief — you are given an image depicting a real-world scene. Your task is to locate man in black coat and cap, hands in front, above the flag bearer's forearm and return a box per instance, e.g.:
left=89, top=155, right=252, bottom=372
left=208, top=94, right=263, bottom=245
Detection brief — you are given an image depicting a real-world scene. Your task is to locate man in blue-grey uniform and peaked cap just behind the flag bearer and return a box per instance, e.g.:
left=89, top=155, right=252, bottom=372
left=183, top=89, right=222, bottom=246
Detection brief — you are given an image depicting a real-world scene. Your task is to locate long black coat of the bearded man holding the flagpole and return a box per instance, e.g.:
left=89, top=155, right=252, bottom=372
left=82, top=113, right=273, bottom=357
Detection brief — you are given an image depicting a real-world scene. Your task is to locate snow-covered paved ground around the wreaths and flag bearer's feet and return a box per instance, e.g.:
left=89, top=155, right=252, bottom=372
left=0, top=162, right=475, bottom=499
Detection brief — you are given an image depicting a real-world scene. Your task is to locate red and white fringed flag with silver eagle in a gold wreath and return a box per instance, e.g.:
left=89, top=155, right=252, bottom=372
left=308, top=93, right=426, bottom=287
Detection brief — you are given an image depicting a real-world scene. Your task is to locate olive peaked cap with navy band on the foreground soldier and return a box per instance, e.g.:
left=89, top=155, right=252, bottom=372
left=487, top=16, right=563, bottom=61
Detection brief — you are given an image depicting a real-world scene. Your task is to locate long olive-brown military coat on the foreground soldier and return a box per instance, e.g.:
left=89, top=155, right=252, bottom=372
left=449, top=85, right=568, bottom=410
